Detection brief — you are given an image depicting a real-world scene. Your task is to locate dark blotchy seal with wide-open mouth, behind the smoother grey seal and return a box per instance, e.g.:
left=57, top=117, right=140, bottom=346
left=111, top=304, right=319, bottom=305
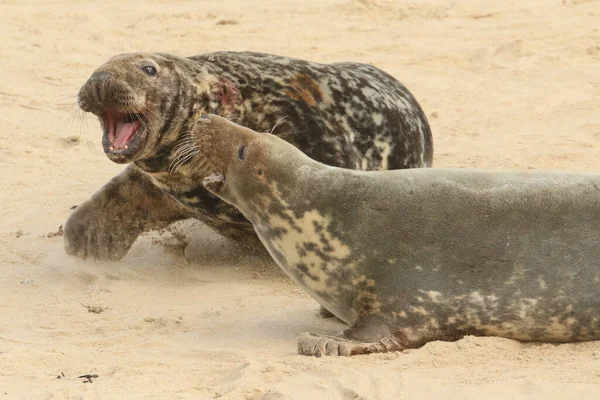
left=64, top=52, right=433, bottom=260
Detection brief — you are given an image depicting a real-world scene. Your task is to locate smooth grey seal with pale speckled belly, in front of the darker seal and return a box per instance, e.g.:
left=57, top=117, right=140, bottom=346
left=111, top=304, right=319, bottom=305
left=194, top=116, right=600, bottom=356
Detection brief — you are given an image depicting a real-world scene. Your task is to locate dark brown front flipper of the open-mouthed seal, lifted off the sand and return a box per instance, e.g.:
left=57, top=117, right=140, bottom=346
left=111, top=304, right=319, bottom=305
left=64, top=165, right=189, bottom=261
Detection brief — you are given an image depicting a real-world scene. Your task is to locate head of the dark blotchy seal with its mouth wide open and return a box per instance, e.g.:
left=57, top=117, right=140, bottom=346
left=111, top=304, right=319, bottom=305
left=77, top=53, right=194, bottom=163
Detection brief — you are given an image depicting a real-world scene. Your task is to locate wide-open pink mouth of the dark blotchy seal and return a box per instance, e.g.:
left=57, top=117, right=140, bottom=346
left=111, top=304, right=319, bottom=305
left=102, top=110, right=147, bottom=158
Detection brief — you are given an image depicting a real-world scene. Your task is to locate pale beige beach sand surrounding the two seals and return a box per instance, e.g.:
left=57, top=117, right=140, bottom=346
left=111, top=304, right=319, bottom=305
left=0, top=0, right=600, bottom=400
